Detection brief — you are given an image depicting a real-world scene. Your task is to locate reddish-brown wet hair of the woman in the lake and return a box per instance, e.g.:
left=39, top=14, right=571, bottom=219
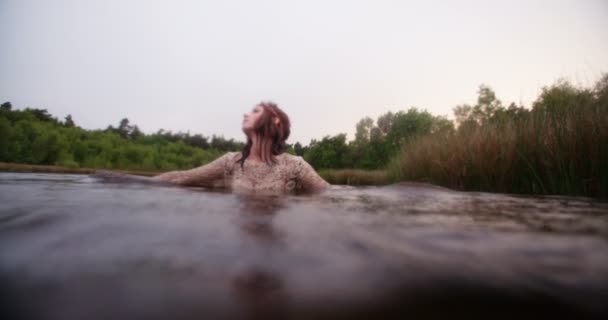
left=237, top=101, right=291, bottom=168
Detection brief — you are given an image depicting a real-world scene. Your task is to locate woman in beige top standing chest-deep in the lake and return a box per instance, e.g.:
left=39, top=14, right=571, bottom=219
left=152, top=102, right=329, bottom=192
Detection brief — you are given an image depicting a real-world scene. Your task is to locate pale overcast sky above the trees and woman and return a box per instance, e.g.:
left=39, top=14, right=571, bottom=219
left=0, top=0, right=608, bottom=144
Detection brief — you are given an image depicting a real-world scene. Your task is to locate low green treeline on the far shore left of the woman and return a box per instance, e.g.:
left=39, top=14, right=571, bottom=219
left=0, top=102, right=243, bottom=171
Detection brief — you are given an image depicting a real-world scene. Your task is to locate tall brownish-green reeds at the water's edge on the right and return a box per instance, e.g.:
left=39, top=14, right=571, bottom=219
left=388, top=80, right=608, bottom=198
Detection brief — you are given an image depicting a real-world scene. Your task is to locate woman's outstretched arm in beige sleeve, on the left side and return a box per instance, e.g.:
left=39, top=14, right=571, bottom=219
left=152, top=152, right=235, bottom=187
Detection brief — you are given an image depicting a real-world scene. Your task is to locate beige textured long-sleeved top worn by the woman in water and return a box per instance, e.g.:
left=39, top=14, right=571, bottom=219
left=153, top=152, right=329, bottom=192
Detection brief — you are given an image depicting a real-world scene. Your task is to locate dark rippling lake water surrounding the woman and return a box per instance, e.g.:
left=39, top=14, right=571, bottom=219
left=0, top=173, right=608, bottom=319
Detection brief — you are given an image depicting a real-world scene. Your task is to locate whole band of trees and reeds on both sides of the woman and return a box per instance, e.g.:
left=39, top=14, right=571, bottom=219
left=0, top=74, right=608, bottom=197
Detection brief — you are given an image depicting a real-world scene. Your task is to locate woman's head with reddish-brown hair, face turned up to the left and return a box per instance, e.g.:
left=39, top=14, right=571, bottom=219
left=239, top=102, right=291, bottom=165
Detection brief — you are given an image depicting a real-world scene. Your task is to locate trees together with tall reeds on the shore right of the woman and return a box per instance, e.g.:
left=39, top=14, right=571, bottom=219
left=303, top=74, right=608, bottom=198
